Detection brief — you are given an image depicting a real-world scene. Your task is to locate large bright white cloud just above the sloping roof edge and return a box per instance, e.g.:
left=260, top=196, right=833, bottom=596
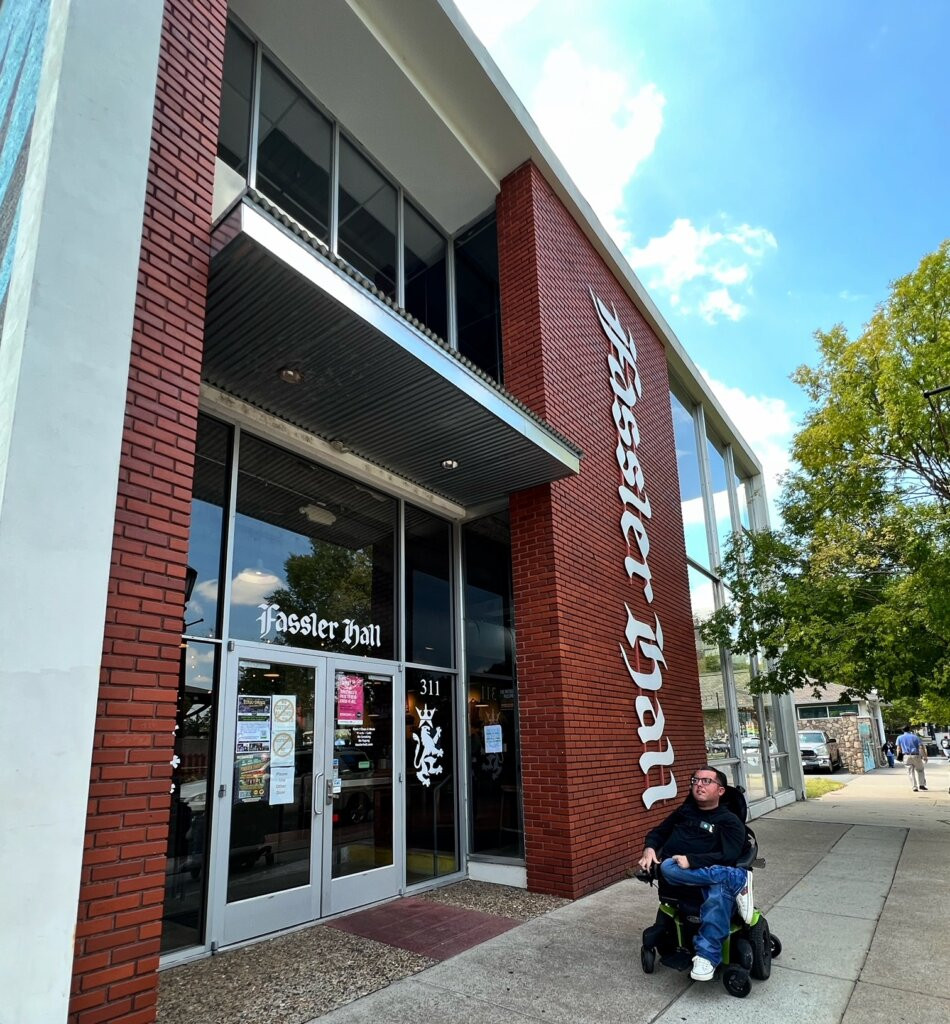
left=529, top=42, right=665, bottom=247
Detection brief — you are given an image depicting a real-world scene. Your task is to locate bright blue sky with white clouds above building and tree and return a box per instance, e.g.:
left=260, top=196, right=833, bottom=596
left=457, top=0, right=950, bottom=499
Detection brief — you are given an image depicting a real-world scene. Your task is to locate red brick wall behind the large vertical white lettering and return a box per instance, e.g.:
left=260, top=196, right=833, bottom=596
left=498, top=164, right=705, bottom=897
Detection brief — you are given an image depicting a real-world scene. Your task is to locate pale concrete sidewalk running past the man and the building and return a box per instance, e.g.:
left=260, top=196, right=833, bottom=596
left=318, top=760, right=950, bottom=1024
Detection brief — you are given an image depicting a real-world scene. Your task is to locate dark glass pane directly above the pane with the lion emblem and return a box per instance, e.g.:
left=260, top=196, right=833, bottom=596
left=405, top=505, right=456, bottom=668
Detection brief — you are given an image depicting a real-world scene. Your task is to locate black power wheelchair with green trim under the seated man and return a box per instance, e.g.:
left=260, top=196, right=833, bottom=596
left=635, top=785, right=782, bottom=998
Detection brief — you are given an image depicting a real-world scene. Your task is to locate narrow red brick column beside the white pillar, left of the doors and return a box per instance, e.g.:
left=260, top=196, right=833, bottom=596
left=70, top=0, right=227, bottom=1024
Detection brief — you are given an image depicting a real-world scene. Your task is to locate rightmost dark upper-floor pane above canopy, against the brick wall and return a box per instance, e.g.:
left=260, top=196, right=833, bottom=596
left=455, top=213, right=503, bottom=381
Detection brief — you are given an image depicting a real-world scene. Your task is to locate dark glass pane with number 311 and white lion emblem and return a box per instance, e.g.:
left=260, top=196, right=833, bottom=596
left=405, top=669, right=459, bottom=885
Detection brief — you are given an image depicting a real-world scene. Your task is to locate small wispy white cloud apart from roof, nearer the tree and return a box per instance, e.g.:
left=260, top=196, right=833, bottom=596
left=627, top=217, right=778, bottom=324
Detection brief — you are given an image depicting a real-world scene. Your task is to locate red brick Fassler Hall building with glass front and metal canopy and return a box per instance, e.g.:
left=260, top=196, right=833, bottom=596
left=0, top=0, right=802, bottom=1024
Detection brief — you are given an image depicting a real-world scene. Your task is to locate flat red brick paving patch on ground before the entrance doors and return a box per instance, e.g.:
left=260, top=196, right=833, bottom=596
left=327, top=896, right=522, bottom=961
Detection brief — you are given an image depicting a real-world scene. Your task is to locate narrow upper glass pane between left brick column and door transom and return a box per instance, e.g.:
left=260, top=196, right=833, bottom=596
left=184, top=416, right=231, bottom=637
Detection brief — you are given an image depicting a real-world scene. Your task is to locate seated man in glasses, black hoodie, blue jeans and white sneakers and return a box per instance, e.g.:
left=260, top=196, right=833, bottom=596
left=638, top=765, right=754, bottom=981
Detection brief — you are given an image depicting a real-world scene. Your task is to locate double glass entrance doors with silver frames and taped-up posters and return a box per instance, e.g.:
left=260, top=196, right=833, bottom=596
left=213, top=644, right=402, bottom=945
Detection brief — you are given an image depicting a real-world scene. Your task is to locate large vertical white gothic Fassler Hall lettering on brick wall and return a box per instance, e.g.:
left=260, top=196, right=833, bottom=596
left=591, top=290, right=677, bottom=809
